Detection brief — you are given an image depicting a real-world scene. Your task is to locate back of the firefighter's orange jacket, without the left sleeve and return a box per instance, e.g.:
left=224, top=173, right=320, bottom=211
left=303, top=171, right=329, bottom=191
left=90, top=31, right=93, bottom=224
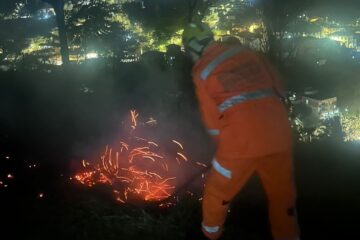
left=199, top=44, right=291, bottom=157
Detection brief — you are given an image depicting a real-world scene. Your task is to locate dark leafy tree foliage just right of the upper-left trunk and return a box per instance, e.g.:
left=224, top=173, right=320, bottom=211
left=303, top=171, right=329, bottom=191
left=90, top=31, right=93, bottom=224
left=68, top=0, right=128, bottom=60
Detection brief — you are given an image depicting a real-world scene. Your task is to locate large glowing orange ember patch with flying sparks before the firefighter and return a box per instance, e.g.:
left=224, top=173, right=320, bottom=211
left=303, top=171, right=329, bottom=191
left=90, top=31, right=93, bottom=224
left=74, top=111, right=204, bottom=207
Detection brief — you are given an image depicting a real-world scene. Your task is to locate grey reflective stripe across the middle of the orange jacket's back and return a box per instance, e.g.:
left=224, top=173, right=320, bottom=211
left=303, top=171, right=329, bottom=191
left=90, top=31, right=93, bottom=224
left=218, top=89, right=276, bottom=112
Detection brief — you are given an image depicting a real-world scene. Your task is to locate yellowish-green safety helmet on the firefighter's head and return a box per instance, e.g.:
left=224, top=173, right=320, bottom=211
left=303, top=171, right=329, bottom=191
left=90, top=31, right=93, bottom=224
left=182, top=23, right=214, bottom=60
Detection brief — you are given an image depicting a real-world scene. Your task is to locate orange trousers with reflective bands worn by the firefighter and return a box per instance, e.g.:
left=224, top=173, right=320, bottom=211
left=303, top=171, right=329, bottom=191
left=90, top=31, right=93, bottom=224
left=202, top=151, right=299, bottom=240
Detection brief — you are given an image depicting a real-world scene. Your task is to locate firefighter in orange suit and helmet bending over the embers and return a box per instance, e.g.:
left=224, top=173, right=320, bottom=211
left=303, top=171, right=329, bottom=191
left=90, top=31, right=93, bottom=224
left=183, top=23, right=299, bottom=240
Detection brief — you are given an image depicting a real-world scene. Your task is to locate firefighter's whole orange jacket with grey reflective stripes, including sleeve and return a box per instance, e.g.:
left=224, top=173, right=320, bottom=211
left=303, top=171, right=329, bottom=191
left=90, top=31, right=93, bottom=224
left=193, top=43, right=291, bottom=157
